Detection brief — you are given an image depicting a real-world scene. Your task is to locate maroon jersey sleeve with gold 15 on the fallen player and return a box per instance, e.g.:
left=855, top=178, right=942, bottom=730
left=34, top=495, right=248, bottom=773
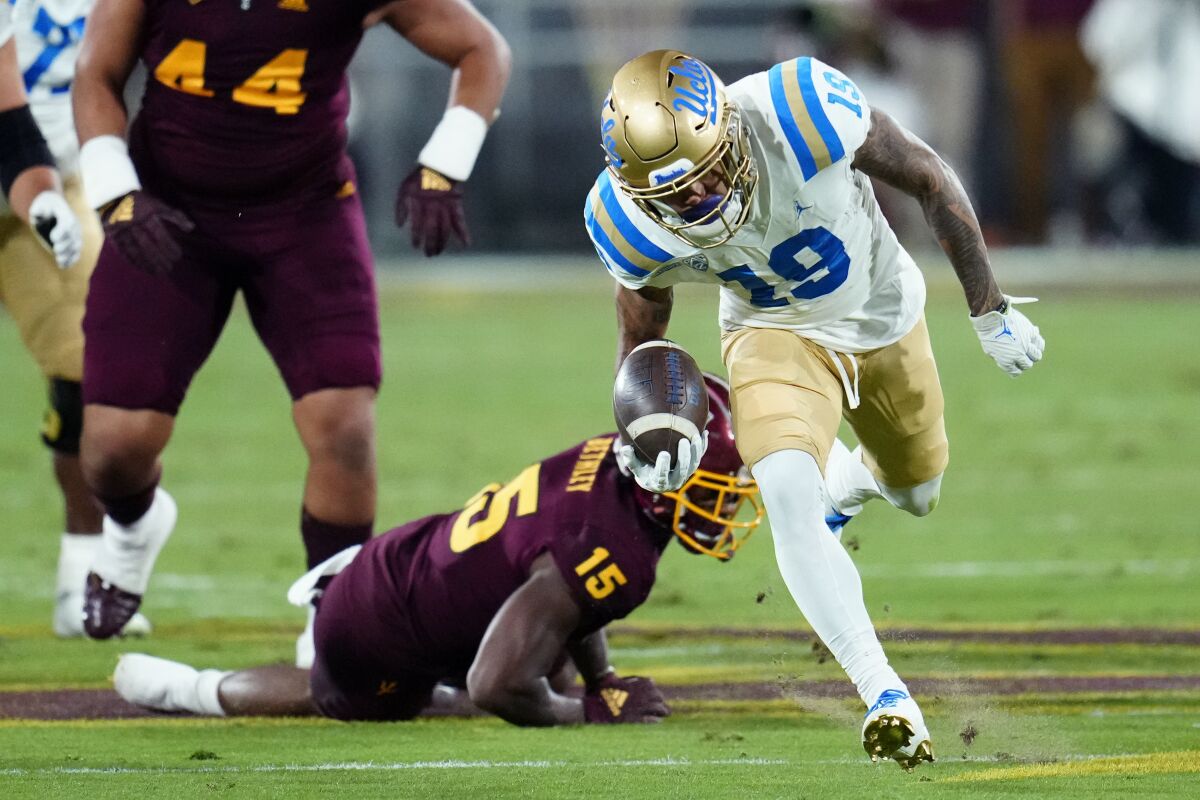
left=548, top=525, right=658, bottom=634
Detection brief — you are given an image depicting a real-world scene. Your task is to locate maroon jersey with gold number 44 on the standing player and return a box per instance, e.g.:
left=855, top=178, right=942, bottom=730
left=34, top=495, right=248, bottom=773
left=130, top=0, right=385, bottom=206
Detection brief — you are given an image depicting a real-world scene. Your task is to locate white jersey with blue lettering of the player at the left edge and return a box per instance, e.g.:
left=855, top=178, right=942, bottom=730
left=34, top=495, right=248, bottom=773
left=8, top=0, right=94, bottom=176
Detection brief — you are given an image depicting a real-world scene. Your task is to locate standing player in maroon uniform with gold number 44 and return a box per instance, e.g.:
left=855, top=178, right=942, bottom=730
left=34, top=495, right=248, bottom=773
left=74, top=0, right=509, bottom=638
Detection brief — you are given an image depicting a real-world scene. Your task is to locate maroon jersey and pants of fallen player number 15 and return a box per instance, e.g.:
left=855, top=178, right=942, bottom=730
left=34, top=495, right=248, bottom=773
left=318, top=434, right=672, bottom=676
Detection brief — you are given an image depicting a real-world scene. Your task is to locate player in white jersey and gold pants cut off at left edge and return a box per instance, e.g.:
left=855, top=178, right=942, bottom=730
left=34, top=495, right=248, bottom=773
left=0, top=0, right=149, bottom=637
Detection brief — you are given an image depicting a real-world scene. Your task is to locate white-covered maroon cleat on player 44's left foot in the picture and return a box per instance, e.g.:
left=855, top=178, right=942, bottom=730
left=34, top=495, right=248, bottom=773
left=83, top=488, right=179, bottom=639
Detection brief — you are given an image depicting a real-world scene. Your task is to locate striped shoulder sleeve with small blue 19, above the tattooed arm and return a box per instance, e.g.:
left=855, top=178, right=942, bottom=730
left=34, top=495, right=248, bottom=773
left=767, top=58, right=871, bottom=180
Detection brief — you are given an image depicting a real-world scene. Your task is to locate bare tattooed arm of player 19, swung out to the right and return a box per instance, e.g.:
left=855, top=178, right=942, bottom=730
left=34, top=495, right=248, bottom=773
left=852, top=110, right=1004, bottom=317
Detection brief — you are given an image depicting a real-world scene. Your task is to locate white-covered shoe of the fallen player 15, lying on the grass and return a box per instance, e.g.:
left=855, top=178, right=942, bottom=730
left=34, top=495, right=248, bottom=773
left=113, top=652, right=229, bottom=716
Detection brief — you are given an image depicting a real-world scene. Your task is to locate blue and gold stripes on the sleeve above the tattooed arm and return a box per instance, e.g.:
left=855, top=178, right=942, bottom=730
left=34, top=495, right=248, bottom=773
left=767, top=58, right=846, bottom=180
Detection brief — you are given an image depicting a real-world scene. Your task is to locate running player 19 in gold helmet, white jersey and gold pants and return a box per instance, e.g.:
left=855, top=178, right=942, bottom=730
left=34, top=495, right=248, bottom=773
left=584, top=50, right=1044, bottom=769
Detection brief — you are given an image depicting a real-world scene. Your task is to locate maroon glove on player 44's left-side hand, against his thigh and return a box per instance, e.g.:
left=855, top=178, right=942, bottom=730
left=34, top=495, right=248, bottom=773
left=100, top=190, right=196, bottom=275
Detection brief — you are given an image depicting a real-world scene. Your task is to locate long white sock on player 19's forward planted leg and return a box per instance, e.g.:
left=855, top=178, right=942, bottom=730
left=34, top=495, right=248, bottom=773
left=752, top=450, right=907, bottom=705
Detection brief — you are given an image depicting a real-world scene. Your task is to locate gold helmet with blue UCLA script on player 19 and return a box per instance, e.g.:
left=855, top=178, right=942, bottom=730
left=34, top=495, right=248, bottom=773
left=600, top=50, right=758, bottom=247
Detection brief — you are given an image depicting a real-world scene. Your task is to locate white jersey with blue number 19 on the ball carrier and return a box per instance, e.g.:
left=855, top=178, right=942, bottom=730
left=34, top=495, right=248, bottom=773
left=584, top=58, right=925, bottom=353
